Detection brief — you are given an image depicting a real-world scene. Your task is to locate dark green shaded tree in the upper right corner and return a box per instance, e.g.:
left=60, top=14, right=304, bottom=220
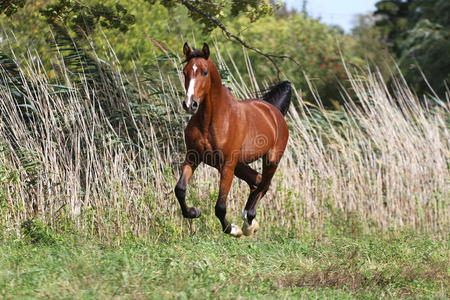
left=375, top=0, right=450, bottom=95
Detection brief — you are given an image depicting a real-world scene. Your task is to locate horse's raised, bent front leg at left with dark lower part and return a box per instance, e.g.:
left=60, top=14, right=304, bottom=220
left=175, top=156, right=200, bottom=219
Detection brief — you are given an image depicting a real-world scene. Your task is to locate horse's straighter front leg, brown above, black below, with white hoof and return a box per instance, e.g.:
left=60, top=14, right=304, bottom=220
left=215, top=161, right=242, bottom=237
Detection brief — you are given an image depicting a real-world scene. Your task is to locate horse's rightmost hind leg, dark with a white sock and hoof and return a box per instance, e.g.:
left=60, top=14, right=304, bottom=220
left=242, top=155, right=279, bottom=236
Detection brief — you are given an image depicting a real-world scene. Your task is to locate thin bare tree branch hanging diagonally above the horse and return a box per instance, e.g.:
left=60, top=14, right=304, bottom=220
left=181, top=0, right=301, bottom=79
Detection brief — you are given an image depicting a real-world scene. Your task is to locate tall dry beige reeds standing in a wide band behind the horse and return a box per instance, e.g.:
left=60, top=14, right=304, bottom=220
left=0, top=37, right=450, bottom=240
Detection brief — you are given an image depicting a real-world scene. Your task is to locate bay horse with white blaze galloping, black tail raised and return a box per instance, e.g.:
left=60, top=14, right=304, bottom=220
left=175, top=43, right=291, bottom=237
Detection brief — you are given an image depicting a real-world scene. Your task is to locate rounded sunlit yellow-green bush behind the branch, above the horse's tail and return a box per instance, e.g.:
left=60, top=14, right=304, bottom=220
left=221, top=14, right=356, bottom=107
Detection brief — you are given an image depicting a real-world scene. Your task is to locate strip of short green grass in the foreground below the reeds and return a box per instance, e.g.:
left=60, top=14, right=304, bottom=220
left=0, top=233, right=450, bottom=299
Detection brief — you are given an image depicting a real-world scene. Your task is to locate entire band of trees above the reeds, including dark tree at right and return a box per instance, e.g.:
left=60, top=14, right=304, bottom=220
left=0, top=0, right=450, bottom=99
